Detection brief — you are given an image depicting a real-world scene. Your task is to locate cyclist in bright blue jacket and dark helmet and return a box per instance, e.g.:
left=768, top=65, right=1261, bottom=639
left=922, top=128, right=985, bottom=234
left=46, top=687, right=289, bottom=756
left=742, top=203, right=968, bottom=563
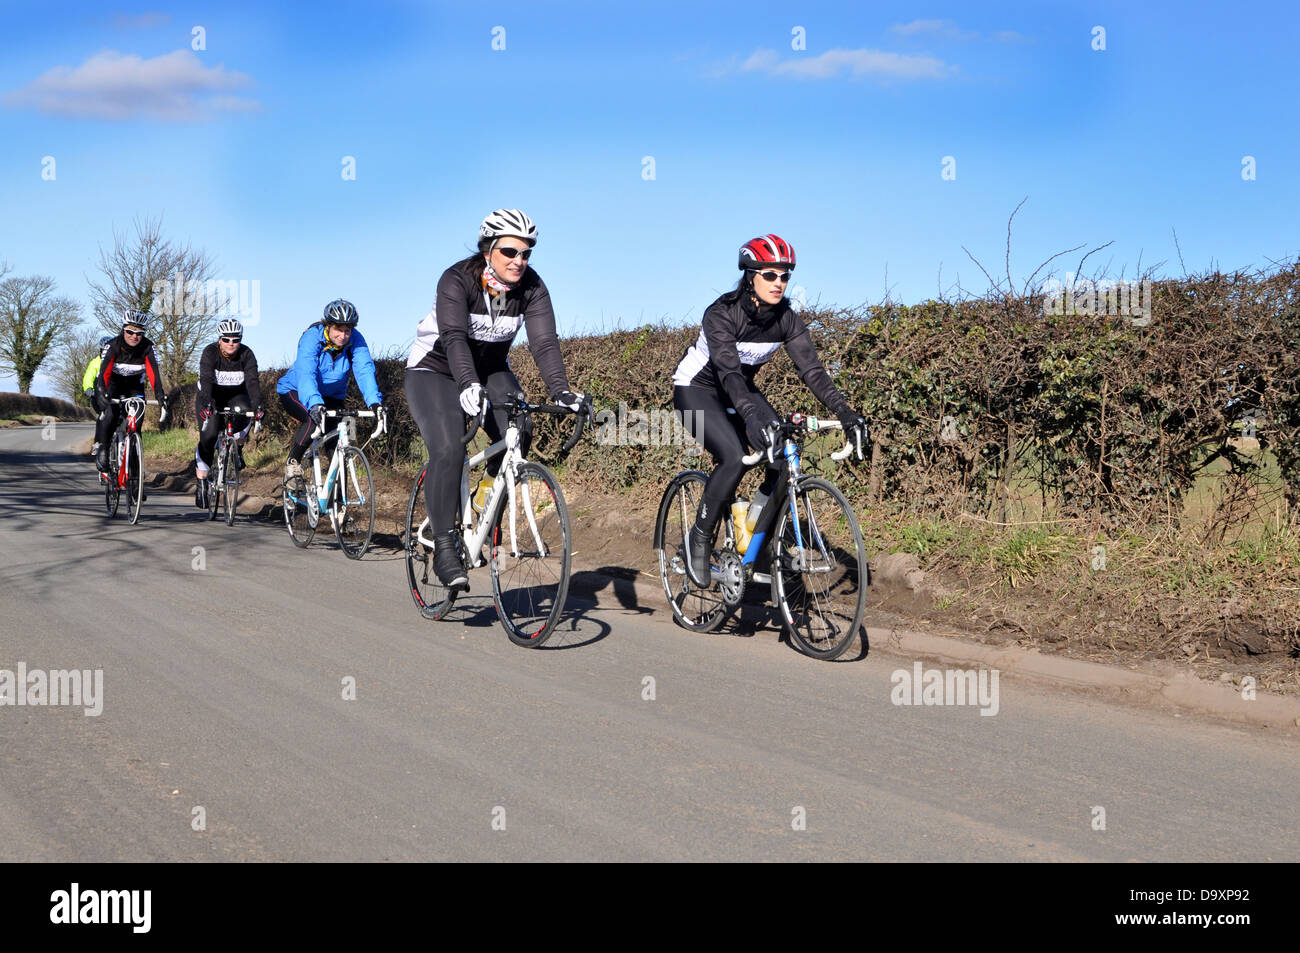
left=276, top=298, right=384, bottom=480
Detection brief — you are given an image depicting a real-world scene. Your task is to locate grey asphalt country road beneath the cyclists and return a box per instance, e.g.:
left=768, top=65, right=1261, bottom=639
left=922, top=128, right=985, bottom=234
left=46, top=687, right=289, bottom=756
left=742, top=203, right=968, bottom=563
left=0, top=424, right=1300, bottom=861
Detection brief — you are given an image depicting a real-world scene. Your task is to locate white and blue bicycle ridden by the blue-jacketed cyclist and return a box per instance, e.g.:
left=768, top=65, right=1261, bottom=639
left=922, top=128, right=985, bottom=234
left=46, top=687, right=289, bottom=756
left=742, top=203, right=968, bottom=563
left=283, top=410, right=387, bottom=559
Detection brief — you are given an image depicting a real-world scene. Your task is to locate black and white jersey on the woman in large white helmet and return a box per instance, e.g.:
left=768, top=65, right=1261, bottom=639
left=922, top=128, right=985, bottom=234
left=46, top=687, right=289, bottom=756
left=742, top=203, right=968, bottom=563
left=407, top=264, right=569, bottom=394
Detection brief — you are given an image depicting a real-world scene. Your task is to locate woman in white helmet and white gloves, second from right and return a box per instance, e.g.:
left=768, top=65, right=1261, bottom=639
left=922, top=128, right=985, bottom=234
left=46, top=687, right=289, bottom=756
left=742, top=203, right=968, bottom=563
left=406, top=208, right=592, bottom=588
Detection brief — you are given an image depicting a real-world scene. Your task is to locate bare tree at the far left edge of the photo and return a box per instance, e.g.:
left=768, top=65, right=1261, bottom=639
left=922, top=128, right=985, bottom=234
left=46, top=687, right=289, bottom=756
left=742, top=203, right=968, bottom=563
left=0, top=274, right=81, bottom=394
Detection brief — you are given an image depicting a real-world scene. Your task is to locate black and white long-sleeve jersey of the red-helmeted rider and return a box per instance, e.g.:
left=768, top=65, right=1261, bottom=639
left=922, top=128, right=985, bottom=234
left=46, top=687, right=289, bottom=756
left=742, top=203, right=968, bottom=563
left=672, top=291, right=849, bottom=416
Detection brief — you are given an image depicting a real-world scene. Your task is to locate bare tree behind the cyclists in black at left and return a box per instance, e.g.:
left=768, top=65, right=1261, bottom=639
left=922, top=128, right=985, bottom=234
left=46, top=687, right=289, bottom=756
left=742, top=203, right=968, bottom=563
left=90, top=217, right=216, bottom=386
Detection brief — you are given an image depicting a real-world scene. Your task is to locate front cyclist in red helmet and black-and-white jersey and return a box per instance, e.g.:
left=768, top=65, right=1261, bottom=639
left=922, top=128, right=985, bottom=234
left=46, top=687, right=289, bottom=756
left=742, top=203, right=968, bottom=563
left=672, top=235, right=867, bottom=588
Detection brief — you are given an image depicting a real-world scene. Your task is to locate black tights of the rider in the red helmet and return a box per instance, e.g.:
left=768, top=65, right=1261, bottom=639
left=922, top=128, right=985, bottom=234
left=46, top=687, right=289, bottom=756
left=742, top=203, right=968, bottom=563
left=672, top=386, right=785, bottom=533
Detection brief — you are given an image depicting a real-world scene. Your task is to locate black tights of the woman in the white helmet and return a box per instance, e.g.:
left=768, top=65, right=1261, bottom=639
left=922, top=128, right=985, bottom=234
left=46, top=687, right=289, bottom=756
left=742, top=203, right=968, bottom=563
left=406, top=368, right=533, bottom=533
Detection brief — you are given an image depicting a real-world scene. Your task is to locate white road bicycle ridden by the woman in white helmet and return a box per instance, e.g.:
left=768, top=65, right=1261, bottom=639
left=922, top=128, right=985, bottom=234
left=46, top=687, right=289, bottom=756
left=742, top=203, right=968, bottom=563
left=402, top=397, right=588, bottom=647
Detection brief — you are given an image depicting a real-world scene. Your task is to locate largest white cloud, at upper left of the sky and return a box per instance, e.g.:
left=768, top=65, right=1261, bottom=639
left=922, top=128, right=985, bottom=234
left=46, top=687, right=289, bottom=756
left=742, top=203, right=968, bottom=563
left=4, top=49, right=259, bottom=120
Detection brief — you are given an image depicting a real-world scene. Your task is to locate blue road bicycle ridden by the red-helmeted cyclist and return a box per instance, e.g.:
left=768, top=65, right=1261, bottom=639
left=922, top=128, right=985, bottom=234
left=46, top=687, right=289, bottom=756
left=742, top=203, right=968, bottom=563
left=654, top=413, right=871, bottom=660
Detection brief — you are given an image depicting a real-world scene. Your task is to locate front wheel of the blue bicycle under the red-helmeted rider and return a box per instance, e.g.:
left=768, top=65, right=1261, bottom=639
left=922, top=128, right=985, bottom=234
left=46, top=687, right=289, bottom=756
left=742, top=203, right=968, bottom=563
left=772, top=477, right=871, bottom=660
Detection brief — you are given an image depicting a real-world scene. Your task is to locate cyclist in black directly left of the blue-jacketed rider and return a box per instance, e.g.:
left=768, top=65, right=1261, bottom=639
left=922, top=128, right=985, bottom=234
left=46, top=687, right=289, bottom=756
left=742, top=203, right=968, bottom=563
left=194, top=317, right=263, bottom=510
